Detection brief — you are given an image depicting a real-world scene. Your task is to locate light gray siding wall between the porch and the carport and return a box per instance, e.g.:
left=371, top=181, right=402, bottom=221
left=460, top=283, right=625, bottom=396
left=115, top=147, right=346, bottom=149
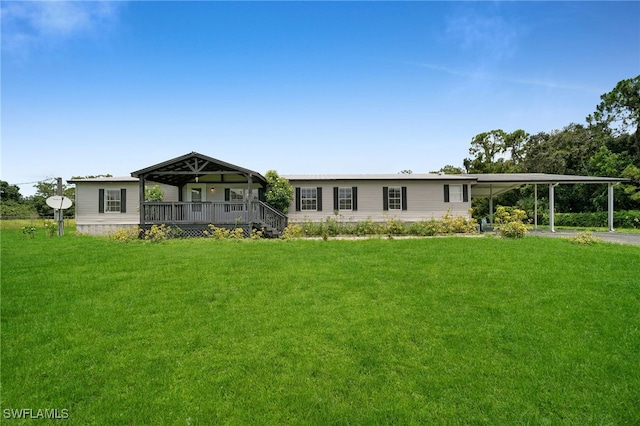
left=288, top=180, right=471, bottom=222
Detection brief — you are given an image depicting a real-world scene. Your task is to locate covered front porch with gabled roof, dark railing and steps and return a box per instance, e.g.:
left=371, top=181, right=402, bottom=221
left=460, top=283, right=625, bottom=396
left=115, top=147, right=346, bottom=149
left=131, top=152, right=287, bottom=235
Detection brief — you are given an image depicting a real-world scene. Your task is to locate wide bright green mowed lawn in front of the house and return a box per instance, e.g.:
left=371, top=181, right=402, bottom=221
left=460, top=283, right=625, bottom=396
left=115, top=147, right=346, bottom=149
left=0, top=230, right=640, bottom=425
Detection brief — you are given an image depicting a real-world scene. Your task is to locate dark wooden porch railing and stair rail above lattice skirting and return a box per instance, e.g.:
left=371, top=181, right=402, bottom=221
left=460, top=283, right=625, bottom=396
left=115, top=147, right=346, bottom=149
left=142, top=201, right=287, bottom=235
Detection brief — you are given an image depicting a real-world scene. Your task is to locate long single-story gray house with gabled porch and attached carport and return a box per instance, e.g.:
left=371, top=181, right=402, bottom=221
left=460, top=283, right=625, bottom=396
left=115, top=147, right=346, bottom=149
left=68, top=152, right=624, bottom=235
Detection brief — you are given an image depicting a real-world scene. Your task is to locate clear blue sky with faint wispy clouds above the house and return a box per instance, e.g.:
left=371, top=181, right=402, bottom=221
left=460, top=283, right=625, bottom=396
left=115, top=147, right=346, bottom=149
left=0, top=1, right=640, bottom=195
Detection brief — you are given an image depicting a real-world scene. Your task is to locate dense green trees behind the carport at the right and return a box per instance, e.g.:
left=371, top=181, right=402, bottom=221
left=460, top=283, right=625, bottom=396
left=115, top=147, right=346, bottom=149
left=438, top=76, right=640, bottom=216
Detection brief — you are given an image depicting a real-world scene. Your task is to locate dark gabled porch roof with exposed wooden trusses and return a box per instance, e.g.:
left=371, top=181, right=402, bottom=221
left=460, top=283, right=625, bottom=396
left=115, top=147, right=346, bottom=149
left=131, top=152, right=267, bottom=187
